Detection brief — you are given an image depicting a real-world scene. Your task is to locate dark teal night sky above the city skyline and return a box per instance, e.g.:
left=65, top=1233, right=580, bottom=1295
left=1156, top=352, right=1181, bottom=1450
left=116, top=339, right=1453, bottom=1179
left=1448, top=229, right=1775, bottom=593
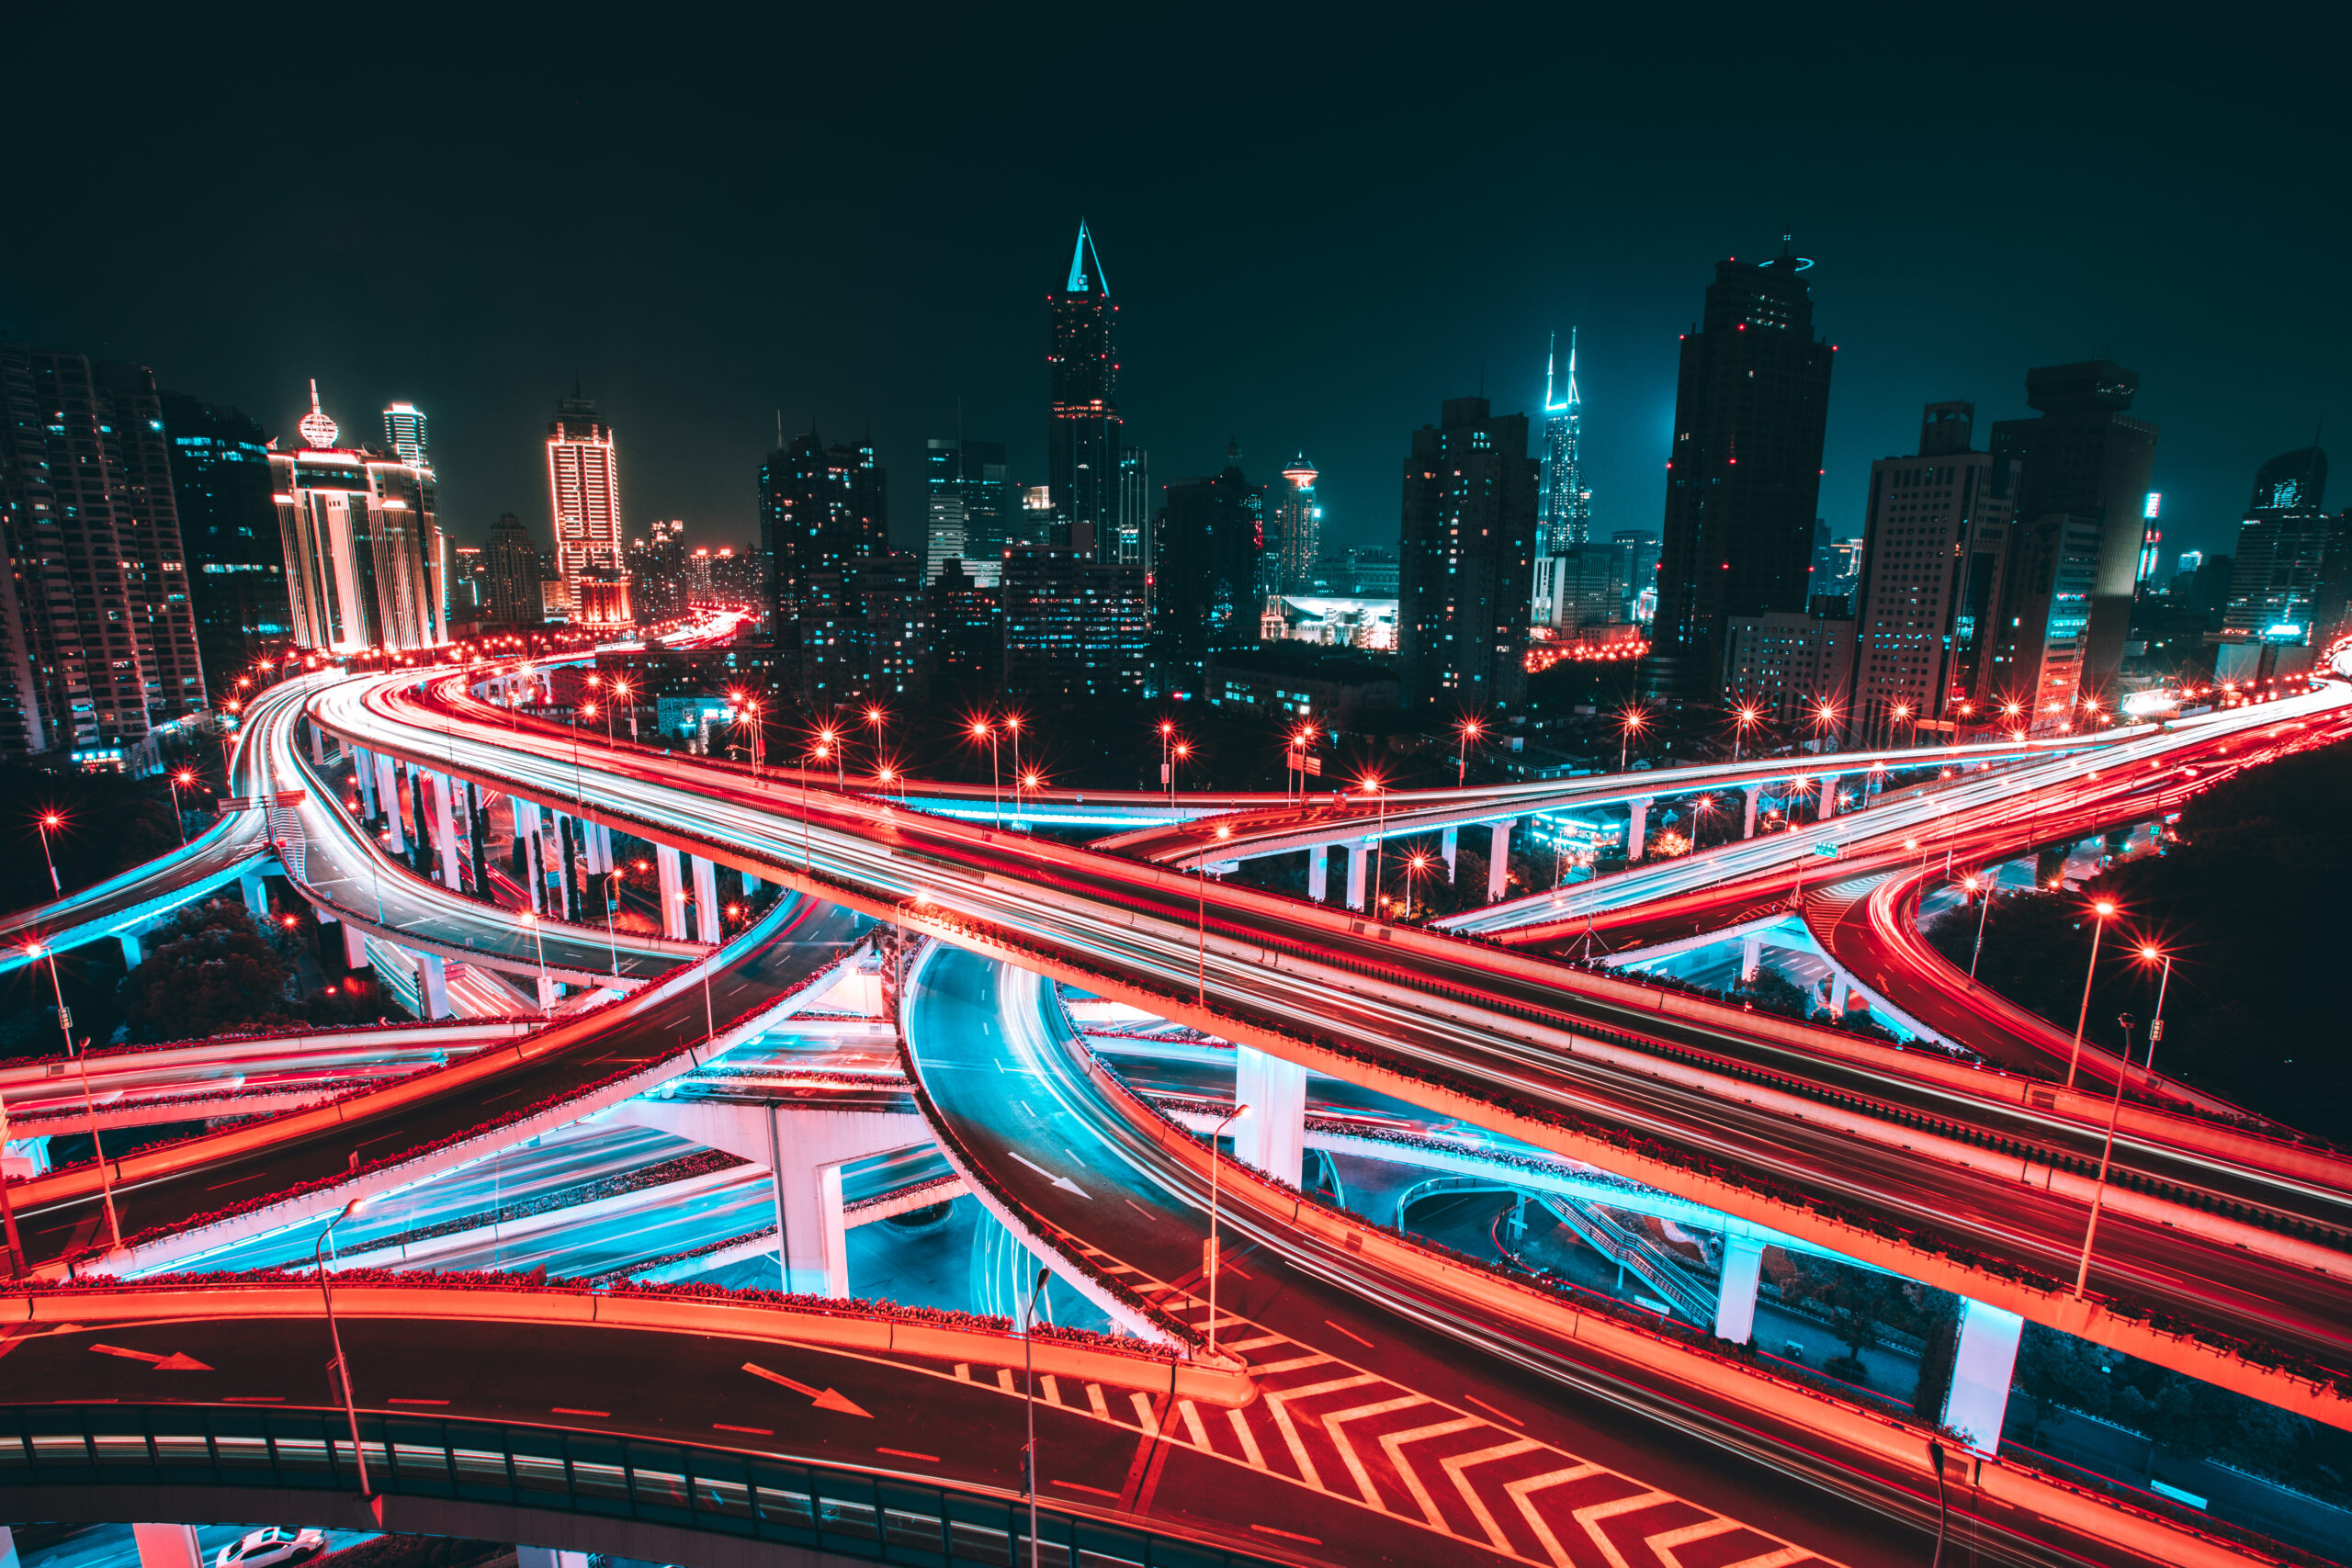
left=0, top=5, right=2352, bottom=570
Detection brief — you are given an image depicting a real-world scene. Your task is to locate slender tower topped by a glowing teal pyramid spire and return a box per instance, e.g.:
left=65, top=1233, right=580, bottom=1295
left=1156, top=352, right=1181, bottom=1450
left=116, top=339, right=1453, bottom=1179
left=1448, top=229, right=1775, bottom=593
left=1045, top=221, right=1122, bottom=552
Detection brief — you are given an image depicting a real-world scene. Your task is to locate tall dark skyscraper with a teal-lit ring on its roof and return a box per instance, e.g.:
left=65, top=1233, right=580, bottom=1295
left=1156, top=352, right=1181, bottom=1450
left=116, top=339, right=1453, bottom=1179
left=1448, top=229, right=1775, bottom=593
left=1642, top=247, right=1835, bottom=701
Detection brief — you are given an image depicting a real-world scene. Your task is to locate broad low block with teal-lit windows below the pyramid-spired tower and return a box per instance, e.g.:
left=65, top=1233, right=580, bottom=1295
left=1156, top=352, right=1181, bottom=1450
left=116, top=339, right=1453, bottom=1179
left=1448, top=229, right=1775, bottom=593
left=997, top=546, right=1152, bottom=703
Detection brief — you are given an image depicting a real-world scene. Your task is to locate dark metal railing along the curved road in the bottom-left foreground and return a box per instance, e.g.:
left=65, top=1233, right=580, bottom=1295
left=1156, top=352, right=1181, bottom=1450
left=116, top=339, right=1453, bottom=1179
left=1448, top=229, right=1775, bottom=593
left=0, top=1405, right=1275, bottom=1568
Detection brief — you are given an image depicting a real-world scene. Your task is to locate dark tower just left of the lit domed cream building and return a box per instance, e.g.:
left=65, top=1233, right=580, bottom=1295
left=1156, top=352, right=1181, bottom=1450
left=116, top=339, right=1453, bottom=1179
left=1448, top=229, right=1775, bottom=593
left=160, top=392, right=294, bottom=691
